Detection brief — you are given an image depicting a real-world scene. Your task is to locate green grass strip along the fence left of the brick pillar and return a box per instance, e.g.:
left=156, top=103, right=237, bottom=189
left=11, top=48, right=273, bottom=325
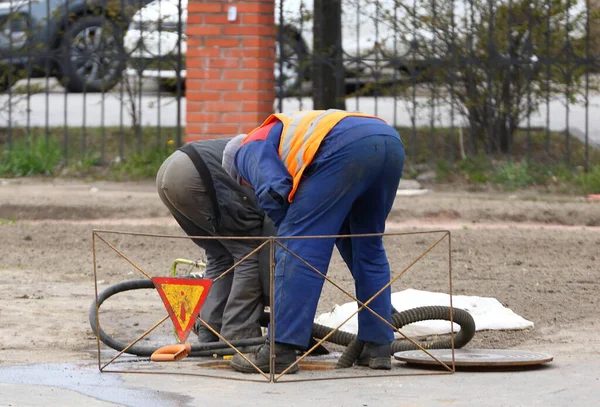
left=0, top=127, right=177, bottom=180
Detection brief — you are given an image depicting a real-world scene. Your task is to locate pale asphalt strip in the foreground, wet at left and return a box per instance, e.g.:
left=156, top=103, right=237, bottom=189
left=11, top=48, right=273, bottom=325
left=0, top=355, right=600, bottom=407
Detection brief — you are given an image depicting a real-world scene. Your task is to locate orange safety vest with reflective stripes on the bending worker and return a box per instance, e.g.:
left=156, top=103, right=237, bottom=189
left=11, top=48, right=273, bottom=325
left=242, top=109, right=384, bottom=202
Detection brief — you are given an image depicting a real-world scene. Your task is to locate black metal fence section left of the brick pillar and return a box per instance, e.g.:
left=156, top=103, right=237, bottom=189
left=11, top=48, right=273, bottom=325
left=0, top=0, right=187, bottom=173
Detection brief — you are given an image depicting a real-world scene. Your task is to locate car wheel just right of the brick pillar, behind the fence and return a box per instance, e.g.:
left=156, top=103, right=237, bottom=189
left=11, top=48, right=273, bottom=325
left=275, top=27, right=310, bottom=97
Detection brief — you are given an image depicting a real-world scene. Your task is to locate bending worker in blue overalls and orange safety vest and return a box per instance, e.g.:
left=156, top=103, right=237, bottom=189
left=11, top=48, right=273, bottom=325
left=224, top=110, right=405, bottom=373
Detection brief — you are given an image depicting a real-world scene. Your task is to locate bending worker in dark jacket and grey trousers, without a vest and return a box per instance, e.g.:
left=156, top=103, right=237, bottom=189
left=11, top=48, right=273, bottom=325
left=156, top=139, right=276, bottom=342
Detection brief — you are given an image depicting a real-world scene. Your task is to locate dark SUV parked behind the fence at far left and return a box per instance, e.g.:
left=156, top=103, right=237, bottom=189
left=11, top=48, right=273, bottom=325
left=0, top=0, right=150, bottom=92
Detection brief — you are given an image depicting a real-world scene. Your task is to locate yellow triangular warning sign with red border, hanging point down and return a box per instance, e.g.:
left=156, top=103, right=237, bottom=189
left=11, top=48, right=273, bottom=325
left=152, top=277, right=212, bottom=343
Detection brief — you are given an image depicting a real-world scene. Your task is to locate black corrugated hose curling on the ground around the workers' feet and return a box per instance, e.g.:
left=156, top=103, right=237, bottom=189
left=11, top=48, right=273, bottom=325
left=89, top=279, right=475, bottom=368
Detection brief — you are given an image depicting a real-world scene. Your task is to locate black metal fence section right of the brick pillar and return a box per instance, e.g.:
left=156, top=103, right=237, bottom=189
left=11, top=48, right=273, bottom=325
left=276, top=0, right=600, bottom=168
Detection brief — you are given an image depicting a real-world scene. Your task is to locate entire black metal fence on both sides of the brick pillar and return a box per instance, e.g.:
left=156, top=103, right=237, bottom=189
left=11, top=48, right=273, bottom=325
left=0, top=0, right=600, bottom=171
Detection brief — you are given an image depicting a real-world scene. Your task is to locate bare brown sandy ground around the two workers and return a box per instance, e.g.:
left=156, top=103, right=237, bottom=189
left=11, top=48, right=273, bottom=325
left=0, top=179, right=600, bottom=365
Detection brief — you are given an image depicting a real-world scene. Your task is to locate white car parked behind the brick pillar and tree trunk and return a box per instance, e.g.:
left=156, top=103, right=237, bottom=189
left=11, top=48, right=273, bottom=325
left=125, top=0, right=432, bottom=93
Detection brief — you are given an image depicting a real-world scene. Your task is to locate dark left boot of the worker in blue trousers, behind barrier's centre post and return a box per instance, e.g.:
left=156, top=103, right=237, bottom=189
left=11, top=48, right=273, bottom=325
left=231, top=343, right=298, bottom=373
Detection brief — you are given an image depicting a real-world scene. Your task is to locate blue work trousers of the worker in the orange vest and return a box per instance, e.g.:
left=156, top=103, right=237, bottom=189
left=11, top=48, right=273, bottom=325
left=232, top=117, right=405, bottom=349
